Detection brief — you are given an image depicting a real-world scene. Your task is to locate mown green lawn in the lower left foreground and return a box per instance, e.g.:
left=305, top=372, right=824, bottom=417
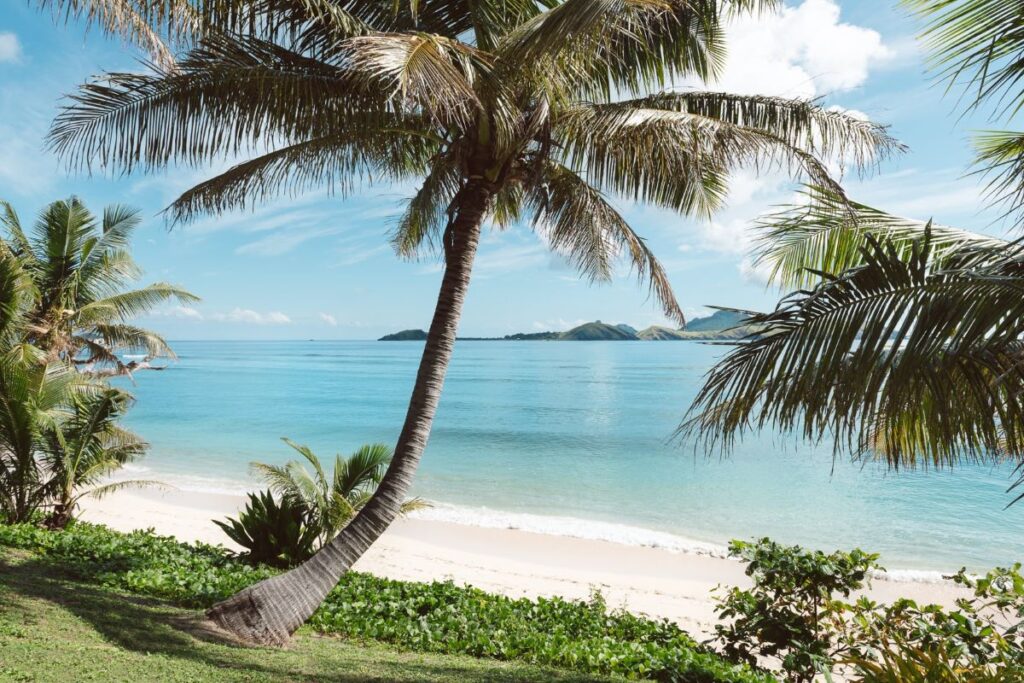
left=0, top=548, right=613, bottom=683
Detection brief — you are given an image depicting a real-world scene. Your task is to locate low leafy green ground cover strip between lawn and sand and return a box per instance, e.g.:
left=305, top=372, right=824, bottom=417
left=0, top=523, right=774, bottom=683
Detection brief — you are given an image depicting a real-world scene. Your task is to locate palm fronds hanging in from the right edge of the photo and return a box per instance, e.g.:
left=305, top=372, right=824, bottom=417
left=682, top=0, right=1024, bottom=502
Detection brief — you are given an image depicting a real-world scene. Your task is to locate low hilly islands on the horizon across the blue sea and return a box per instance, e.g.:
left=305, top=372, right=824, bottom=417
left=378, top=310, right=758, bottom=341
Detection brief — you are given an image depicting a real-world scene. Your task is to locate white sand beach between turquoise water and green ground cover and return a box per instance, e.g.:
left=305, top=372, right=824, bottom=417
left=82, top=490, right=964, bottom=637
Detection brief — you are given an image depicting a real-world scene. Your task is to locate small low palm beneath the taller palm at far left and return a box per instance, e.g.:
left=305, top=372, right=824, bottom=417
left=38, top=387, right=153, bottom=528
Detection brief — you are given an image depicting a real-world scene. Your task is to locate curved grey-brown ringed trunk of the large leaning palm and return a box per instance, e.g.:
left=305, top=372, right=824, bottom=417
left=207, top=181, right=492, bottom=645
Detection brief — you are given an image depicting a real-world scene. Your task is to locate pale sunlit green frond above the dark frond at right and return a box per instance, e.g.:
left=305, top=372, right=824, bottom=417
left=753, top=185, right=1006, bottom=290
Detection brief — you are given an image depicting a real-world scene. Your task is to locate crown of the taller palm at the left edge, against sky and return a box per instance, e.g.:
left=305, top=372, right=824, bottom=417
left=0, top=198, right=198, bottom=374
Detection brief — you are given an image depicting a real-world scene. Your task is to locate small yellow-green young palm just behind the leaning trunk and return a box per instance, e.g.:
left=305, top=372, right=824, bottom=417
left=252, top=438, right=426, bottom=546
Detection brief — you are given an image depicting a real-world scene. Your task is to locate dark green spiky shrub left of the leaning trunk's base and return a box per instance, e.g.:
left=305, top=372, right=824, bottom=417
left=213, top=490, right=319, bottom=568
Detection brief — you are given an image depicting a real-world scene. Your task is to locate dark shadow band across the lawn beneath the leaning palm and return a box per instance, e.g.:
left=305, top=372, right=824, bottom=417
left=0, top=555, right=605, bottom=683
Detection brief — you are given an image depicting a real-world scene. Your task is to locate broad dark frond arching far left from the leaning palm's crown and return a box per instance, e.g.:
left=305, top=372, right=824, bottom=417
left=48, top=38, right=394, bottom=171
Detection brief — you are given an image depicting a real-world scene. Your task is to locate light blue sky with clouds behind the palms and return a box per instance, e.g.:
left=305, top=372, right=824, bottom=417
left=0, top=0, right=1006, bottom=340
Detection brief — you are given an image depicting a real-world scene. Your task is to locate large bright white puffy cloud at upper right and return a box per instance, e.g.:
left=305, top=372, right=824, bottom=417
left=714, top=0, right=895, bottom=97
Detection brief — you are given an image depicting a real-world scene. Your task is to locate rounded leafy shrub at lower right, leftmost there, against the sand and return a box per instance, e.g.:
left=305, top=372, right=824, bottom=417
left=715, top=539, right=878, bottom=681
